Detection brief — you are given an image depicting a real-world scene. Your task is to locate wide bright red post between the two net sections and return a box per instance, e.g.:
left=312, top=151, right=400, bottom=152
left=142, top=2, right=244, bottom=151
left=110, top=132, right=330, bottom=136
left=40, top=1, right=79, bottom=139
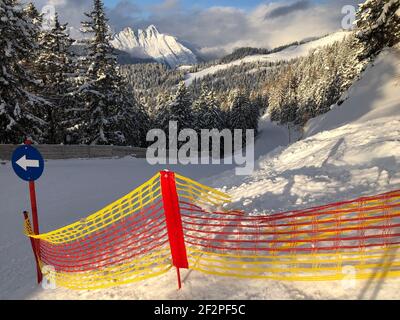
left=160, top=171, right=189, bottom=289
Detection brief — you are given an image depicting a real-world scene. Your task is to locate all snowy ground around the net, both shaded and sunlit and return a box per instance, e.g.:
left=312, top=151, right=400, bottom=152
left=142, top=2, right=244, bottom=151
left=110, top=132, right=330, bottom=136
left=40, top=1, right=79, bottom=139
left=0, top=45, right=400, bottom=299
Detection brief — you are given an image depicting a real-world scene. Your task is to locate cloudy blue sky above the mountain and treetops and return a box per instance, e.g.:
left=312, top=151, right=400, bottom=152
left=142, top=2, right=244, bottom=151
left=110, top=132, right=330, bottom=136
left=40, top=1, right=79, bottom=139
left=33, top=0, right=362, bottom=57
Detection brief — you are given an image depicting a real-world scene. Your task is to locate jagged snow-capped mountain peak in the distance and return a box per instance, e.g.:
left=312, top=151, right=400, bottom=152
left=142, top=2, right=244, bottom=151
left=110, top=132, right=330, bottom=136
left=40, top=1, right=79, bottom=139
left=111, top=25, right=197, bottom=68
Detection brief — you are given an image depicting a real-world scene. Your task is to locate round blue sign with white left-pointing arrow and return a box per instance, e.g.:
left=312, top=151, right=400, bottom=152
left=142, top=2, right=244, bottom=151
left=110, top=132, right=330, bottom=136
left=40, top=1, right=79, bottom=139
left=11, top=144, right=44, bottom=181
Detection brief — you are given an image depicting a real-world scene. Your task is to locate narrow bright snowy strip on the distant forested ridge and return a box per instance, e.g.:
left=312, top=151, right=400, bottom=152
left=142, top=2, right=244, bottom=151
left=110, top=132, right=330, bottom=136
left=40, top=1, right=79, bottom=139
left=185, top=31, right=349, bottom=86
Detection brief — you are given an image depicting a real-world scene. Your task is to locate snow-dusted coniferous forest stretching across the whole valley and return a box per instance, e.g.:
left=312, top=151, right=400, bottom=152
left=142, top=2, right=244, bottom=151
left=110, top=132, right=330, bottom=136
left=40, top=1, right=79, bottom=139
left=0, top=0, right=400, bottom=146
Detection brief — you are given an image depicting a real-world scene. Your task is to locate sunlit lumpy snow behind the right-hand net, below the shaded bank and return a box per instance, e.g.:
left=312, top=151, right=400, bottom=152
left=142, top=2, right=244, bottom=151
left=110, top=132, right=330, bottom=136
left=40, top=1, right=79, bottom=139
left=208, top=117, right=400, bottom=214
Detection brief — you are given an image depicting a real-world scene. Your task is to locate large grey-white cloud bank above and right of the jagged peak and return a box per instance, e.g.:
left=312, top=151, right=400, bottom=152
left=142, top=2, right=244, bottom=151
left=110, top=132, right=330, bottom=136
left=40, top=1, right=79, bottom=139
left=137, top=0, right=359, bottom=56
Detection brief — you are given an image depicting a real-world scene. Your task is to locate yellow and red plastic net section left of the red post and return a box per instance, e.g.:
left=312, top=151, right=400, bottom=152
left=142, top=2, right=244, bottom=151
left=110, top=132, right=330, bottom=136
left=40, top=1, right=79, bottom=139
left=25, top=173, right=230, bottom=289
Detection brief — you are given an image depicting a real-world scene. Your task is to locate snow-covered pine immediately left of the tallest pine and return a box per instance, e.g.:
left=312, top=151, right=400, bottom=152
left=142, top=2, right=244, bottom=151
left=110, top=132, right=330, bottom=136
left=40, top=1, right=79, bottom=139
left=35, top=14, right=76, bottom=144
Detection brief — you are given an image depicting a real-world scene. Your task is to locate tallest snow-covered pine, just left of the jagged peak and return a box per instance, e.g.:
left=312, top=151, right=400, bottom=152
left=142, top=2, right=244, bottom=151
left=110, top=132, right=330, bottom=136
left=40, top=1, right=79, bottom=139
left=75, top=0, right=136, bottom=145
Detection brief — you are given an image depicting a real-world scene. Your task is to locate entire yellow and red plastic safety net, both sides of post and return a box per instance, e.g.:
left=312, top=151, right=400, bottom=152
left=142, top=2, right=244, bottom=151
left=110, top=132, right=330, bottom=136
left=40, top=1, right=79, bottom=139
left=25, top=173, right=400, bottom=289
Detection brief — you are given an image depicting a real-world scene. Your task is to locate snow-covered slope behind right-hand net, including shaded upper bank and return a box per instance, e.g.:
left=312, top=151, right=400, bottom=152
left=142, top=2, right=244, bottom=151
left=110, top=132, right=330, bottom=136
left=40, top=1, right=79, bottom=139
left=209, top=48, right=400, bottom=213
